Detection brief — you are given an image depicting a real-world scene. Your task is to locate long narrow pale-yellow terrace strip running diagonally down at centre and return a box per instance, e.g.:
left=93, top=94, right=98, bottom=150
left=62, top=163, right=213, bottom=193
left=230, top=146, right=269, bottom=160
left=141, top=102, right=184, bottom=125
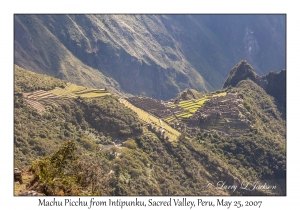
left=120, top=99, right=180, bottom=141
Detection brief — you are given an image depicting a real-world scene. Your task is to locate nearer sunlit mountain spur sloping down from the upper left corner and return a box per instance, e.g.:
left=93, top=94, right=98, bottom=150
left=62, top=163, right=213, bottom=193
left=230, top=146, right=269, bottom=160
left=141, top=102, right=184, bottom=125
left=14, top=15, right=121, bottom=92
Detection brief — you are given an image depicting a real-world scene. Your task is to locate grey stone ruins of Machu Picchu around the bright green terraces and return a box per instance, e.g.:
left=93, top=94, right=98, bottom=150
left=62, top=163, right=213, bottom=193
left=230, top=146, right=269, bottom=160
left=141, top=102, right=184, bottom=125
left=126, top=93, right=250, bottom=137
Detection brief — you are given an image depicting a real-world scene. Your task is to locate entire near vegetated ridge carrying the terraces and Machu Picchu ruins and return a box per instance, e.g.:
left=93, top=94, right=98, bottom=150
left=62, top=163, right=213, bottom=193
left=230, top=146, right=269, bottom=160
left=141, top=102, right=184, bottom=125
left=14, top=65, right=286, bottom=196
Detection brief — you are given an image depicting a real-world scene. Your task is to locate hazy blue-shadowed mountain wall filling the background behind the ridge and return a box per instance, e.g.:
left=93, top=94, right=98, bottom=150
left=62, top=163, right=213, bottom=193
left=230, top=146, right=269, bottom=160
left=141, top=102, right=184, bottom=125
left=14, top=14, right=286, bottom=100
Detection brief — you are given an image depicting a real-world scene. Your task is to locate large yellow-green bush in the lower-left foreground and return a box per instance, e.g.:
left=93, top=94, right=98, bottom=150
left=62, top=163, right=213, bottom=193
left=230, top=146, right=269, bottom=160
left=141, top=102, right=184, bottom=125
left=30, top=141, right=112, bottom=196
